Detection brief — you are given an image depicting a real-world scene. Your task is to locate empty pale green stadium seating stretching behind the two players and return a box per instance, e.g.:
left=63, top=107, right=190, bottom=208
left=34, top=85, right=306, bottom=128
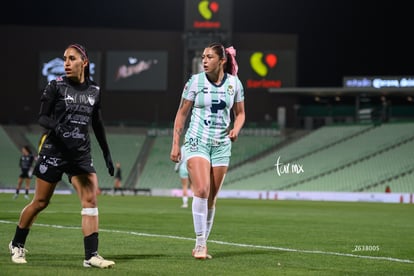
left=0, top=122, right=414, bottom=193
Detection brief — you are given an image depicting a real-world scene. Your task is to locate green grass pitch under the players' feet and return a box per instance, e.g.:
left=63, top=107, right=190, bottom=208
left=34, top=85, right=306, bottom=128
left=0, top=194, right=414, bottom=276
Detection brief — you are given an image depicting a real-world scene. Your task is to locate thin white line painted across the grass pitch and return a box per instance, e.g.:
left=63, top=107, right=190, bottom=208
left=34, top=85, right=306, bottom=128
left=0, top=220, right=414, bottom=264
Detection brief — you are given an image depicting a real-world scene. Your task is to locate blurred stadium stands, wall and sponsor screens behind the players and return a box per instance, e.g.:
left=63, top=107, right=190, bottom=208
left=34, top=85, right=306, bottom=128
left=0, top=0, right=414, bottom=202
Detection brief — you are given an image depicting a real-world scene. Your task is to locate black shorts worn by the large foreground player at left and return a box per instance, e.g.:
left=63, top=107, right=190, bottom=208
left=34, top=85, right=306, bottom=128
left=33, top=155, right=96, bottom=183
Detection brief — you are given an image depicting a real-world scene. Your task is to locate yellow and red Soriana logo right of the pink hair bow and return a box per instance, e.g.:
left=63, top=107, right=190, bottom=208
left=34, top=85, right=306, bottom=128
left=247, top=52, right=282, bottom=88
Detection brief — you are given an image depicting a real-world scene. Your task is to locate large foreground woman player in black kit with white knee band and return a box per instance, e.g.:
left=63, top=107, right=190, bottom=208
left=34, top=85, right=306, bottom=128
left=9, top=44, right=115, bottom=268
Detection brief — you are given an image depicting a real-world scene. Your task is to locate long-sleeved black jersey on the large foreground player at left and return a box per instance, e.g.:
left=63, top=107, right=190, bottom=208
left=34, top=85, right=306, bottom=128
left=39, top=77, right=109, bottom=158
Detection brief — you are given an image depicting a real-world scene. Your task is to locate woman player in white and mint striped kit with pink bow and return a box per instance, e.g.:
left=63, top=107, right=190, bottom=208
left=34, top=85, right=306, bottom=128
left=170, top=43, right=245, bottom=259
